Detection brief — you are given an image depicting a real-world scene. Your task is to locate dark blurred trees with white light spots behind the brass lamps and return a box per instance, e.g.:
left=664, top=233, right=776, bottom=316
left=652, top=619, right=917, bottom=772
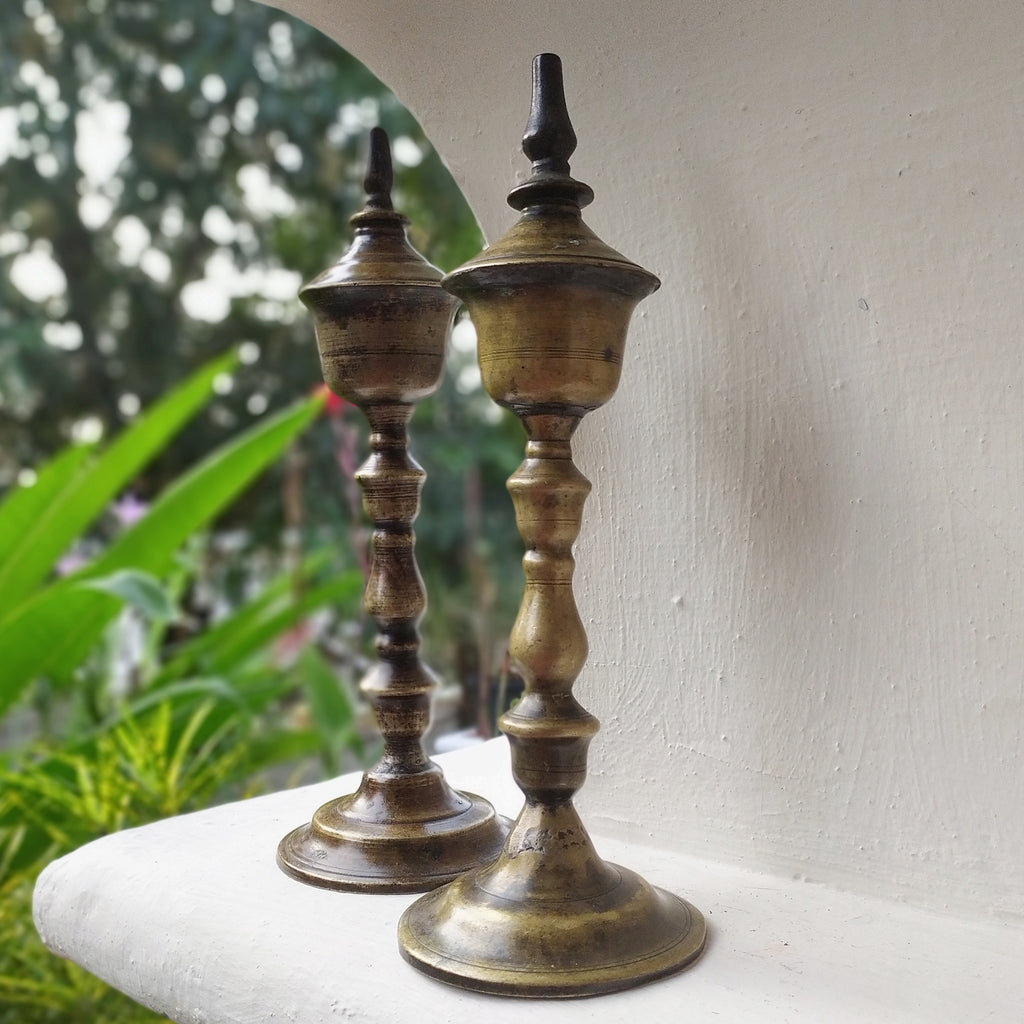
left=0, top=0, right=521, bottom=696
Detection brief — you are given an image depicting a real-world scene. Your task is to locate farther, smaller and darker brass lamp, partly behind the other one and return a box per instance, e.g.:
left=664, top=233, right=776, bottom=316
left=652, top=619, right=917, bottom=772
left=278, top=128, right=508, bottom=892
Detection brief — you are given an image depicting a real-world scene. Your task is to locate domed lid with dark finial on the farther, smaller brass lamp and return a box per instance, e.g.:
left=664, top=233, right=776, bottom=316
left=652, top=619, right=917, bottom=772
left=299, top=128, right=441, bottom=299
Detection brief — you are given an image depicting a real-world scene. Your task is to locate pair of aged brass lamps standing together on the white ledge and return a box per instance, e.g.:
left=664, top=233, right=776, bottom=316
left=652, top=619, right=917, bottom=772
left=278, top=53, right=706, bottom=997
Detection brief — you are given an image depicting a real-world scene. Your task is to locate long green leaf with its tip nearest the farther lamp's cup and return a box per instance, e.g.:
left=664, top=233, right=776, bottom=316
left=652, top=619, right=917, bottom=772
left=0, top=398, right=321, bottom=713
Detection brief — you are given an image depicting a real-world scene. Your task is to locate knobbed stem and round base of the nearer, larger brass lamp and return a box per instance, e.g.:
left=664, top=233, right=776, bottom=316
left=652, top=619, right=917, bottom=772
left=398, top=389, right=705, bottom=996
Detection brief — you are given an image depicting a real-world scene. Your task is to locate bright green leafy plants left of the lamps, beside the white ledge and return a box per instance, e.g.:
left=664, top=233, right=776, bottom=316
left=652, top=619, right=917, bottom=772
left=0, top=357, right=366, bottom=1024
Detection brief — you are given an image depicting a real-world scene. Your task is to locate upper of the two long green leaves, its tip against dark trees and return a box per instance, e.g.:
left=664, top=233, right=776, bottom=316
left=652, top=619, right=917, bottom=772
left=0, top=353, right=237, bottom=618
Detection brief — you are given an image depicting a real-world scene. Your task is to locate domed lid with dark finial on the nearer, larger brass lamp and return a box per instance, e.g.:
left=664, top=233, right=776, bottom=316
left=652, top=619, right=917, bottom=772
left=441, top=53, right=660, bottom=299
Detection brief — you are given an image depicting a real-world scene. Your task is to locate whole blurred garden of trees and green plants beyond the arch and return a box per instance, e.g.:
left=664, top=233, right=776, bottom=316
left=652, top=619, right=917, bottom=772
left=0, top=0, right=522, bottom=1024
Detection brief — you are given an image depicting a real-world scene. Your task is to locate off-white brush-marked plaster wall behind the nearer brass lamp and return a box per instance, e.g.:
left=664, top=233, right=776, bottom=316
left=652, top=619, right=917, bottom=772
left=266, top=0, right=1024, bottom=916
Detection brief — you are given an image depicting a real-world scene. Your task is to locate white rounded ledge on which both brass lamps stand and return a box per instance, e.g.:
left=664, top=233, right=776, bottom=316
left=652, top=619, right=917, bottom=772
left=36, top=739, right=1024, bottom=1024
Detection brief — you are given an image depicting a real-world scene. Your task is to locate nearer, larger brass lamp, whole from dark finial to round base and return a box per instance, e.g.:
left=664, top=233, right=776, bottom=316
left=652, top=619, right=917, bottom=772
left=399, top=54, right=706, bottom=996
